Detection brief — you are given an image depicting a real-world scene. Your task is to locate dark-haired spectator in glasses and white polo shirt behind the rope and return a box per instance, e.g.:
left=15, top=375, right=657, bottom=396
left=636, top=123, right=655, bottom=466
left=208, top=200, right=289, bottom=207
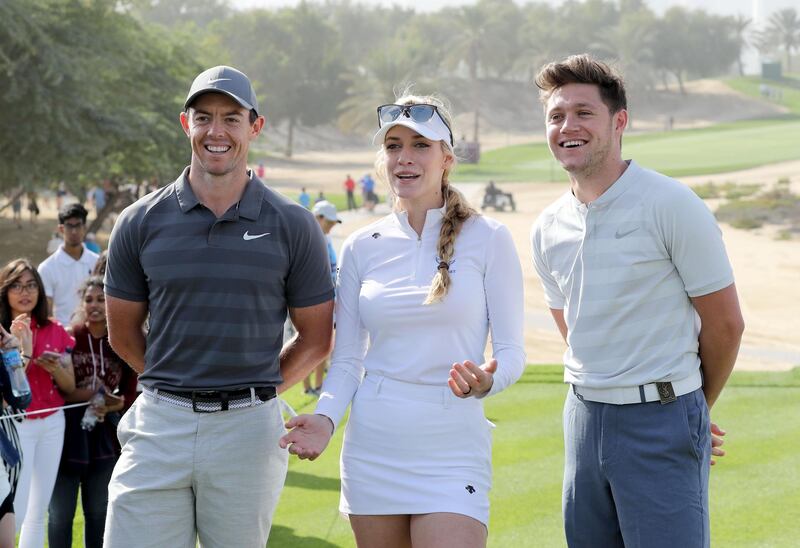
left=38, top=203, right=97, bottom=326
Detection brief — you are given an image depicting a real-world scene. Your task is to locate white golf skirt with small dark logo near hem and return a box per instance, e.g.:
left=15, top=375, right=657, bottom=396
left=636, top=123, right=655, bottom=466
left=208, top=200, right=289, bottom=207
left=339, top=374, right=493, bottom=526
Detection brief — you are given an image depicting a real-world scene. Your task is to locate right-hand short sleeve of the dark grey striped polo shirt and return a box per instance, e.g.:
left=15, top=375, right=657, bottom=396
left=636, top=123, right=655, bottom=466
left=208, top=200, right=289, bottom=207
left=286, top=210, right=333, bottom=308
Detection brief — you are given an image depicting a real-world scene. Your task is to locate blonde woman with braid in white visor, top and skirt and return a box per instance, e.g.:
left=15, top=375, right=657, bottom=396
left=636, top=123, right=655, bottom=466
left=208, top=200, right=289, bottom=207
left=281, top=95, right=525, bottom=548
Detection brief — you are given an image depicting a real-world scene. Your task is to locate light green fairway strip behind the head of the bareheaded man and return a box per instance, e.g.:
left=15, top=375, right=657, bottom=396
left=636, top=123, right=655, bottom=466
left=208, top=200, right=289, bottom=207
left=453, top=116, right=800, bottom=183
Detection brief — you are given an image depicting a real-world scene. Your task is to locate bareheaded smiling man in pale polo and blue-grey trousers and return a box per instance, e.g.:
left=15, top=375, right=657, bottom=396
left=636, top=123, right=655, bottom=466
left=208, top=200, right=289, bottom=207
left=531, top=55, right=744, bottom=548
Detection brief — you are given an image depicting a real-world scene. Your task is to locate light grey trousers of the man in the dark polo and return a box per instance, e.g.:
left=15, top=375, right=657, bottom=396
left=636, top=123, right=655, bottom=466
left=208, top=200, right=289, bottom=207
left=104, top=392, right=288, bottom=548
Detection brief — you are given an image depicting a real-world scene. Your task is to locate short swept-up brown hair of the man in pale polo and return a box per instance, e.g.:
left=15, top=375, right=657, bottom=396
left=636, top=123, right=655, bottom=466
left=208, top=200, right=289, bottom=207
left=534, top=53, right=628, bottom=114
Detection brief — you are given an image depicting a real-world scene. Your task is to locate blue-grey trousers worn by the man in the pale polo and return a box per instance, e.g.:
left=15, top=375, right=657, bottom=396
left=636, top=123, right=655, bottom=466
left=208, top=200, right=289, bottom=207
left=563, top=389, right=711, bottom=548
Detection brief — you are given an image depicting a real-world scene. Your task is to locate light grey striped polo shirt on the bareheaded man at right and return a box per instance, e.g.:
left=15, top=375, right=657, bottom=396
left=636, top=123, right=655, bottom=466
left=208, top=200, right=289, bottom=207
left=531, top=161, right=733, bottom=388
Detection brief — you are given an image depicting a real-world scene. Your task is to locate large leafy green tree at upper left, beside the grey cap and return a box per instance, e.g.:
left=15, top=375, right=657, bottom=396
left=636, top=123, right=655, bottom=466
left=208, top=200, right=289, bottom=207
left=0, top=0, right=197, bottom=195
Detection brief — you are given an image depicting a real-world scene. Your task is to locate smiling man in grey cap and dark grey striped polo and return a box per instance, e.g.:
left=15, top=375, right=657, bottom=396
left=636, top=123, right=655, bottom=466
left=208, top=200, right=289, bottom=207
left=105, top=66, right=333, bottom=548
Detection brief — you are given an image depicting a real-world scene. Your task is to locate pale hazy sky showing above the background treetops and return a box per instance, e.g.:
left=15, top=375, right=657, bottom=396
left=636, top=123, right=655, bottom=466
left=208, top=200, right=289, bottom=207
left=229, top=0, right=800, bottom=23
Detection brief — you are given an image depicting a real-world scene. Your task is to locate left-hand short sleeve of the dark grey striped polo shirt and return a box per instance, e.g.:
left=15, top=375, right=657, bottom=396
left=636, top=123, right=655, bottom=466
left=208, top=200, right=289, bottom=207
left=104, top=207, right=149, bottom=302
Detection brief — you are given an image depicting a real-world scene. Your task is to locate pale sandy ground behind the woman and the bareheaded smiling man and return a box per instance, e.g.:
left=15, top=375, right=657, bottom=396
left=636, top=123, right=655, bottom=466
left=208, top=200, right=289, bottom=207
left=324, top=162, right=800, bottom=370
